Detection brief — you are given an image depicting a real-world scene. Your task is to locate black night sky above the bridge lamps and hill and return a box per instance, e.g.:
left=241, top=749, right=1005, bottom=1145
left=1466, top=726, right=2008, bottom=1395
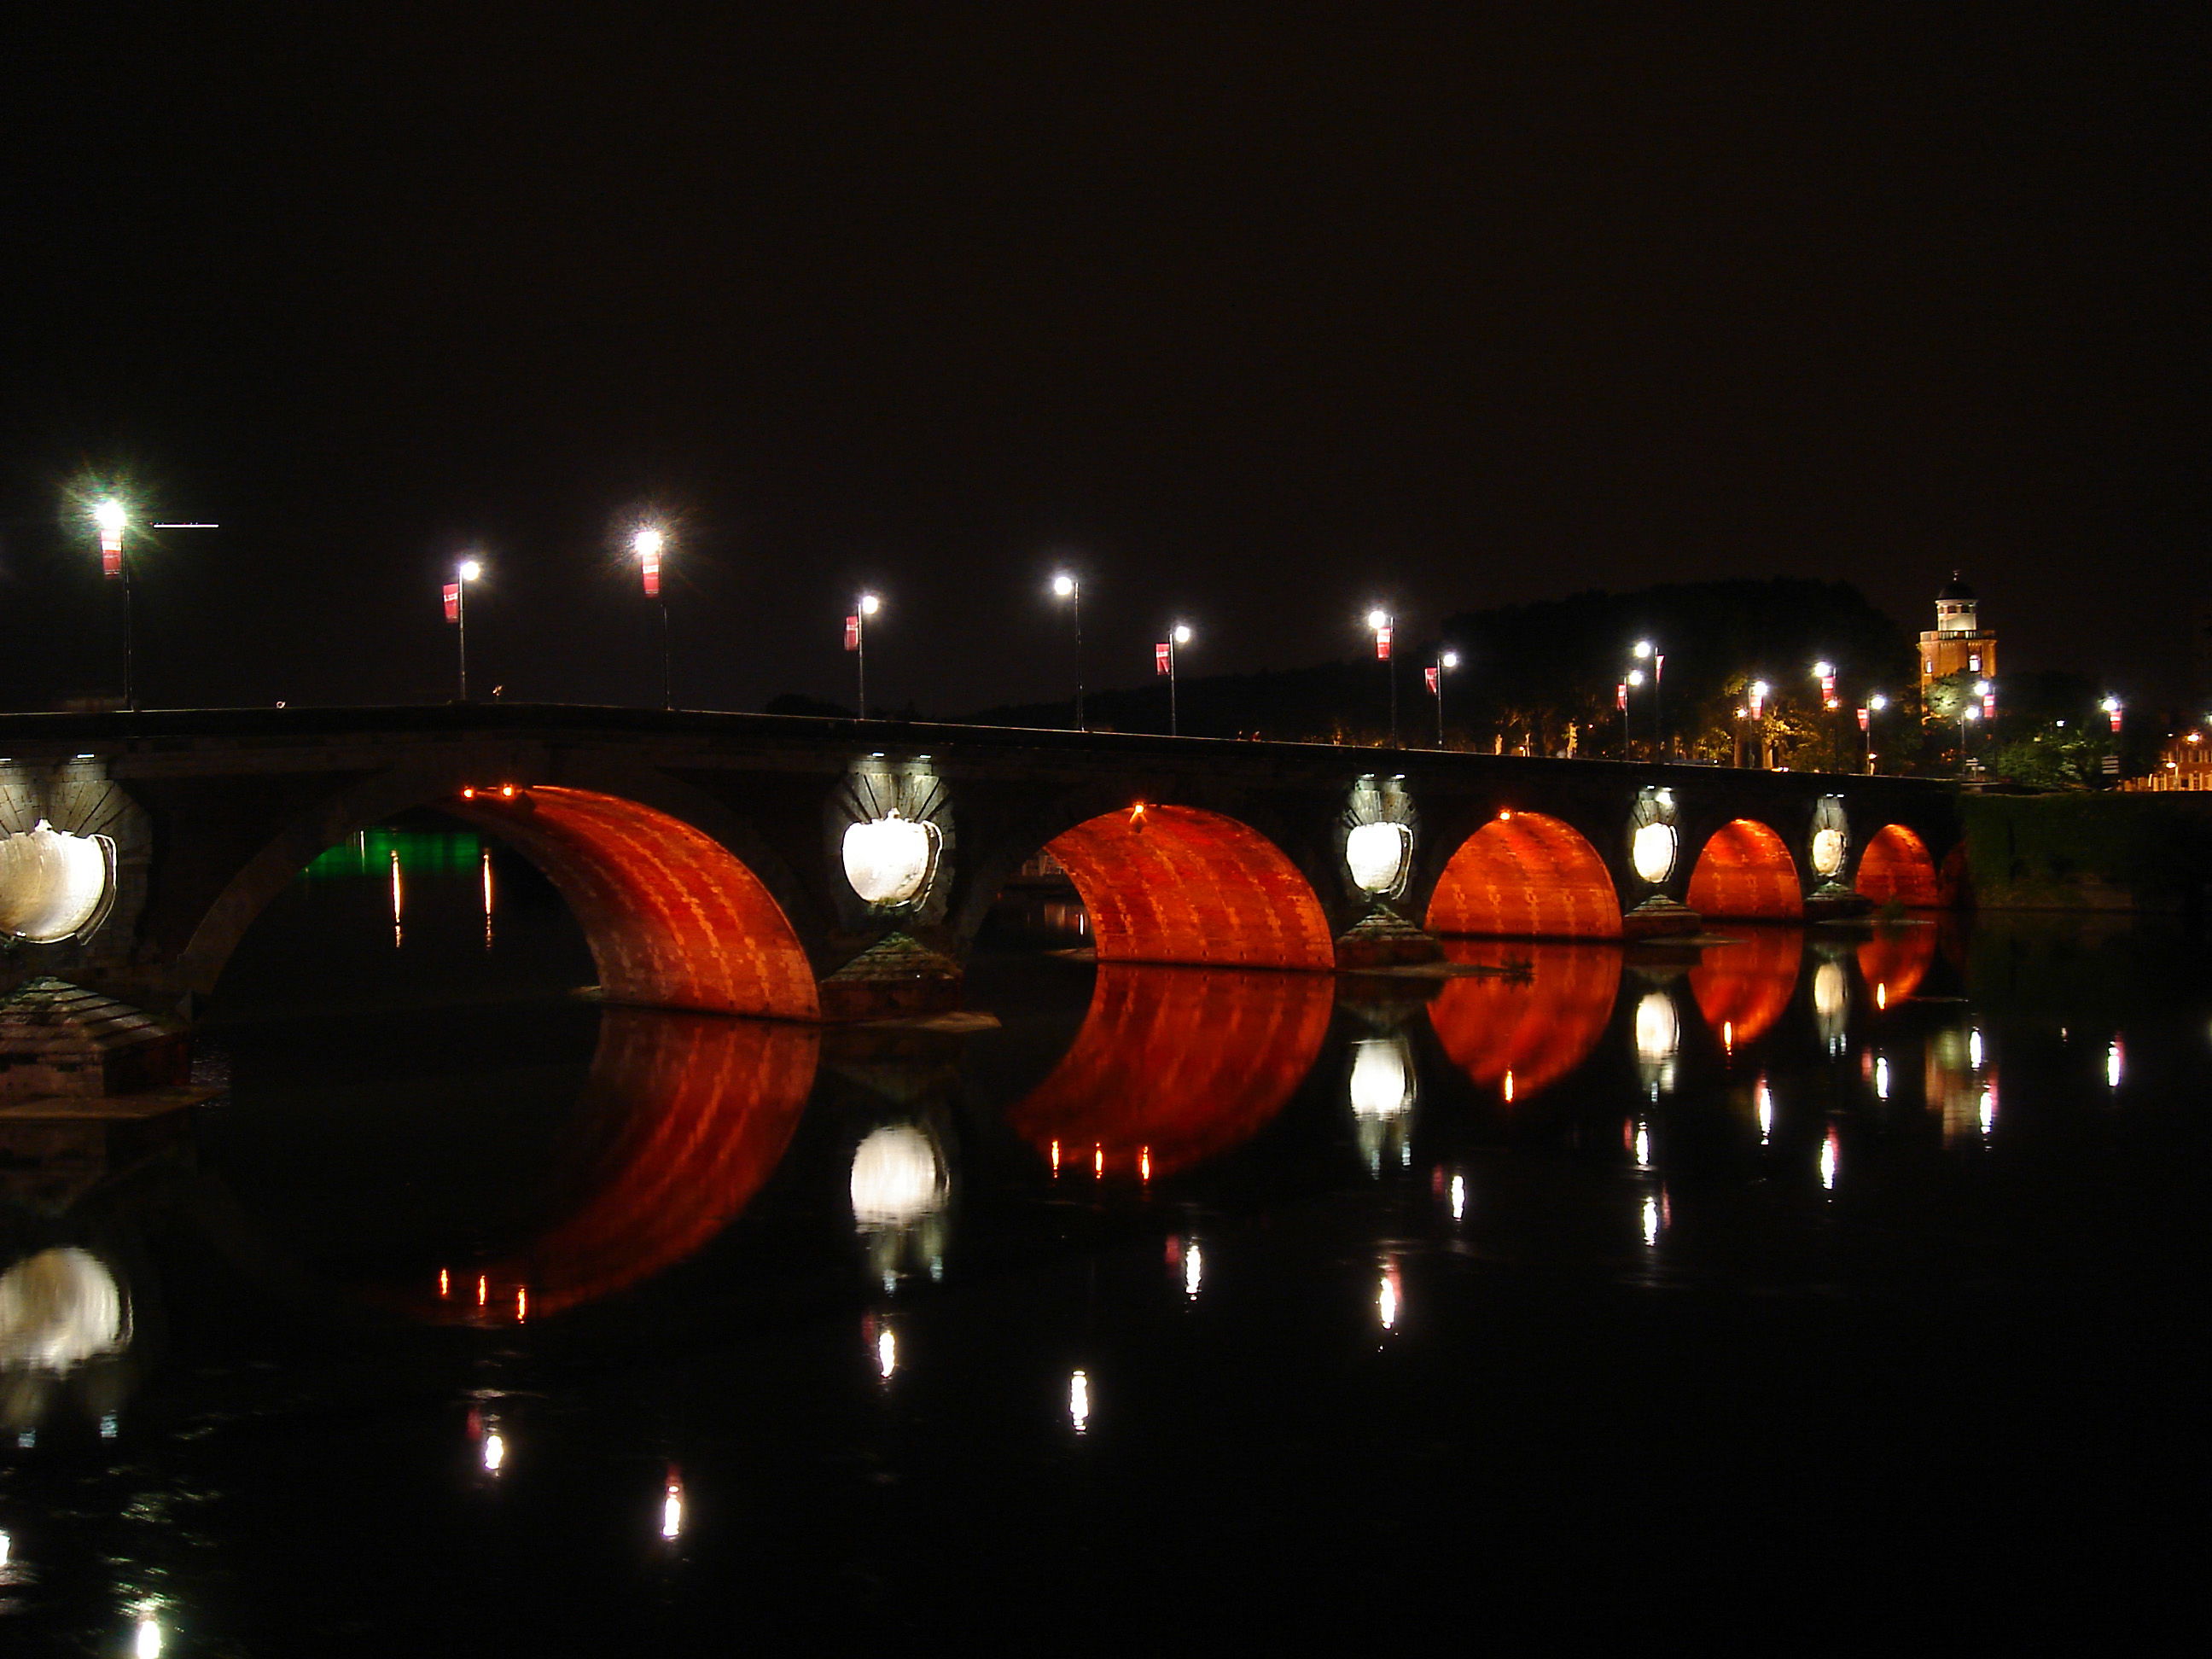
left=0, top=4, right=2212, bottom=713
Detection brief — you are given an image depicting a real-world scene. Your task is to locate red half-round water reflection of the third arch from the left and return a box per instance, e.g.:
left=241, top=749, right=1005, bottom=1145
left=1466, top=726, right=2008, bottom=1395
left=1429, top=940, right=1621, bottom=1099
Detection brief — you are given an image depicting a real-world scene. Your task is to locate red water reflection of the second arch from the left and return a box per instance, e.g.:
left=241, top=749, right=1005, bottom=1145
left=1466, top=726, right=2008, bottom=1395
left=1006, top=964, right=1336, bottom=1174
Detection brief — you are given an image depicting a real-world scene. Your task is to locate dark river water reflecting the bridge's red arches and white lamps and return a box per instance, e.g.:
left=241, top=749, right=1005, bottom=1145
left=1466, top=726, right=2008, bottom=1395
left=0, top=827, right=2212, bottom=1655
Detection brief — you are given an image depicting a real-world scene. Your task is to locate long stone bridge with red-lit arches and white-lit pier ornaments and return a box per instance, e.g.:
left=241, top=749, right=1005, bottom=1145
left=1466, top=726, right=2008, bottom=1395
left=0, top=703, right=1960, bottom=1020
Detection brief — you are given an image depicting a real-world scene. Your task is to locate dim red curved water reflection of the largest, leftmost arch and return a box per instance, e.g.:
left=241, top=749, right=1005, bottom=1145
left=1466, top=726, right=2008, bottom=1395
left=413, top=1009, right=821, bottom=1323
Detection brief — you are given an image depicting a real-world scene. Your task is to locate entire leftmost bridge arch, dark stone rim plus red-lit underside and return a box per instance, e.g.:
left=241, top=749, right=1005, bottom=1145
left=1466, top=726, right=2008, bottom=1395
left=182, top=774, right=821, bottom=1020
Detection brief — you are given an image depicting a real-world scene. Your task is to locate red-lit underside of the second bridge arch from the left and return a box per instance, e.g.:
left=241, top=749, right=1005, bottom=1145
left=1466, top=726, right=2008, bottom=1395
left=1046, top=805, right=1336, bottom=969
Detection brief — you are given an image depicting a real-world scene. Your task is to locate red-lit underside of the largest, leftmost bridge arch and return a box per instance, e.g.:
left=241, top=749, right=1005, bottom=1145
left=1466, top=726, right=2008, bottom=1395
left=449, top=788, right=821, bottom=1020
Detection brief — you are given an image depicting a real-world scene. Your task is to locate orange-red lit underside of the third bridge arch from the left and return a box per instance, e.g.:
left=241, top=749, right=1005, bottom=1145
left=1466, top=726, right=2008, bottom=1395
left=1429, top=812, right=1621, bottom=938
